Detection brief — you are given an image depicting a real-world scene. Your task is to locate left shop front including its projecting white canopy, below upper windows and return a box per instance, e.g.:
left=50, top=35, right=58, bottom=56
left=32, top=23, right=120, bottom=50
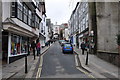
left=2, top=18, right=39, bottom=63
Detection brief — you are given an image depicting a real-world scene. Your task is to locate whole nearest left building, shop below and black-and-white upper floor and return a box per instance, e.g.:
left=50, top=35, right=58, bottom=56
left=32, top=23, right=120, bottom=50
left=2, top=0, right=42, bottom=63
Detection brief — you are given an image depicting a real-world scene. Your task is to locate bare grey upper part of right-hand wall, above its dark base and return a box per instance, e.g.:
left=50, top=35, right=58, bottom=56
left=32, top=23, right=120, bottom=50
left=96, top=2, right=118, bottom=53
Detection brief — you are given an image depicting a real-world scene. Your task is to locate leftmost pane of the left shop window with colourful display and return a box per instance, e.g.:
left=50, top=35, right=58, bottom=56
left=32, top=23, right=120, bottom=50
left=11, top=35, right=20, bottom=55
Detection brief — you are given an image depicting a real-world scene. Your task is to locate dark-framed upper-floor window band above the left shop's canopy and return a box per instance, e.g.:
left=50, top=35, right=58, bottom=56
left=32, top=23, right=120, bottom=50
left=11, top=0, right=35, bottom=28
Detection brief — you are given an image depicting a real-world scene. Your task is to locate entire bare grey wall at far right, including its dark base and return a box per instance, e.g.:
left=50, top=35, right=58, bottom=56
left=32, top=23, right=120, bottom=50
left=96, top=2, right=120, bottom=66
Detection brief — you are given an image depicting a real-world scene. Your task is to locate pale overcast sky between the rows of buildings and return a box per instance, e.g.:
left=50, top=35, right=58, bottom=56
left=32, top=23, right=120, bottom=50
left=45, top=0, right=78, bottom=24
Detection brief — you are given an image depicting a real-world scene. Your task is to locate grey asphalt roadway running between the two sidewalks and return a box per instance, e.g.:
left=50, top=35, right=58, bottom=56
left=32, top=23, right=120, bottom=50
left=38, top=42, right=94, bottom=78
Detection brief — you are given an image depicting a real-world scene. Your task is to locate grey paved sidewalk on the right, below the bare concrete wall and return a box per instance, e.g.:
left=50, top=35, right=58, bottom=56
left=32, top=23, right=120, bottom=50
left=74, top=48, right=120, bottom=78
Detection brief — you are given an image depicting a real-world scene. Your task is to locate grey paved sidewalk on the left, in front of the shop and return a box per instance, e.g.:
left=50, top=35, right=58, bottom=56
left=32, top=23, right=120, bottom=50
left=2, top=47, right=49, bottom=79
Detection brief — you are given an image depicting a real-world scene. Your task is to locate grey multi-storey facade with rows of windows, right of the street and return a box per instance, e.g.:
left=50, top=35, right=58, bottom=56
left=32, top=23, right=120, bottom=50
left=69, top=2, right=89, bottom=48
